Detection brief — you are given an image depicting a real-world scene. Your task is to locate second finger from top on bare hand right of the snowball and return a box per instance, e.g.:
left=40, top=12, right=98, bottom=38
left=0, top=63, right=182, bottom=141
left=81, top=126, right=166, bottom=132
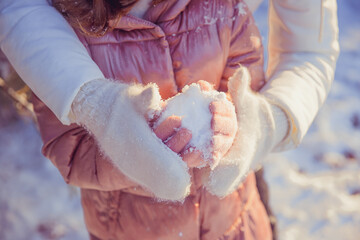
left=211, top=115, right=237, bottom=136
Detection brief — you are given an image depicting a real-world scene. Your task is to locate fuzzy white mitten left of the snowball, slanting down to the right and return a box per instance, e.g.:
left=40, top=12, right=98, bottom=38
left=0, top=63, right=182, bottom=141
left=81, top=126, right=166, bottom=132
left=70, top=79, right=191, bottom=200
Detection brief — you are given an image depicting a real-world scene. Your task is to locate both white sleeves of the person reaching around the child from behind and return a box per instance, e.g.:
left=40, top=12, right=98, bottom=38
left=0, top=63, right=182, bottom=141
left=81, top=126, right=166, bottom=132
left=0, top=0, right=339, bottom=150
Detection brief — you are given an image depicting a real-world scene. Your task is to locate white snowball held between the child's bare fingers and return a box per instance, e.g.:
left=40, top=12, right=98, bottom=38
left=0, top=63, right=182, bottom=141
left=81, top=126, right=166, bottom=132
left=156, top=83, right=226, bottom=160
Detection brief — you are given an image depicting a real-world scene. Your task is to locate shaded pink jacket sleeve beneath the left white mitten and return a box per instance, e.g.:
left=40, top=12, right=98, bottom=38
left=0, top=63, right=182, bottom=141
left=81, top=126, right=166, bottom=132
left=32, top=95, right=137, bottom=190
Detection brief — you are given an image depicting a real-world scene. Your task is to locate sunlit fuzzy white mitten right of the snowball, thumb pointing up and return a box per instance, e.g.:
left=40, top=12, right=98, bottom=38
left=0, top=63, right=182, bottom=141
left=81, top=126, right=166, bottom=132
left=206, top=67, right=289, bottom=197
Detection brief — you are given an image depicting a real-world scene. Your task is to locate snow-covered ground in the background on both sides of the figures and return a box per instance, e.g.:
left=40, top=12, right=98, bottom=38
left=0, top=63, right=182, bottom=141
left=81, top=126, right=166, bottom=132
left=0, top=0, right=360, bottom=240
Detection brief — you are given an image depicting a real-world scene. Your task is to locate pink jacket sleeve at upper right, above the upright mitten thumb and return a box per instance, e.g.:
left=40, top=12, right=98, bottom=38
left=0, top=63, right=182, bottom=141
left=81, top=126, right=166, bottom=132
left=220, top=0, right=265, bottom=91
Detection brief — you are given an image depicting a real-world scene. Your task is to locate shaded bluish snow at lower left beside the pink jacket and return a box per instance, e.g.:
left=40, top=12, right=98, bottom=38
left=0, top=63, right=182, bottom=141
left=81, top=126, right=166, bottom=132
left=0, top=121, right=87, bottom=240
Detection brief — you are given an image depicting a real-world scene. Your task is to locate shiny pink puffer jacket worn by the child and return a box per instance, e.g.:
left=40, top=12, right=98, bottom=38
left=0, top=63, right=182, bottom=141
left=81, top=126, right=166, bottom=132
left=33, top=0, right=271, bottom=240
